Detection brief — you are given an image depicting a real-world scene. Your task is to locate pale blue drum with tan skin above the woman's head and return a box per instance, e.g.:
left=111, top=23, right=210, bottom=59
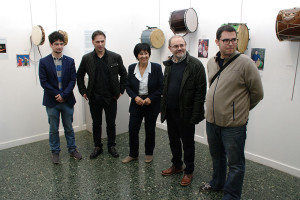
left=141, top=28, right=165, bottom=49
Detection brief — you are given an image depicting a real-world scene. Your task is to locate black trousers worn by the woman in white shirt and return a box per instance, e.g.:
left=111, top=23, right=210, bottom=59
left=129, top=106, right=158, bottom=158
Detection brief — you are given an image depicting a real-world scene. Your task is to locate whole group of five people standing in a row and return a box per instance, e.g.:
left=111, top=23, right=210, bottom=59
left=39, top=25, right=263, bottom=199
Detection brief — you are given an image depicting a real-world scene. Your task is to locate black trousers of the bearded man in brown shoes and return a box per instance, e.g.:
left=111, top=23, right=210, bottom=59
left=166, top=109, right=195, bottom=174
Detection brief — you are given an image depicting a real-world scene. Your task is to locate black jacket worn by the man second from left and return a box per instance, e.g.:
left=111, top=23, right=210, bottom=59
left=77, top=49, right=127, bottom=98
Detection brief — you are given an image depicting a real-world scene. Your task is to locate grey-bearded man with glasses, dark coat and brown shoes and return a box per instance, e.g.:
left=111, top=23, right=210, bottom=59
left=161, top=35, right=207, bottom=186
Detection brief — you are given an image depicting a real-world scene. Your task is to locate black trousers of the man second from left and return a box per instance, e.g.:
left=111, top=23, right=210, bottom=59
left=90, top=99, right=117, bottom=148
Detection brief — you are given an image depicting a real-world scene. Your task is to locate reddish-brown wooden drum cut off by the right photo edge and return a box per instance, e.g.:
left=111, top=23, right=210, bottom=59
left=275, top=8, right=300, bottom=41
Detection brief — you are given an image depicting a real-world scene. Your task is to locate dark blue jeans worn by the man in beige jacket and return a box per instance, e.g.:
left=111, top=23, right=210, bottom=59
left=206, top=122, right=247, bottom=200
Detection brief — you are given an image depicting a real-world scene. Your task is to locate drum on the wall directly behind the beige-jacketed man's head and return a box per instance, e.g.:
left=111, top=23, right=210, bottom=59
left=223, top=23, right=249, bottom=53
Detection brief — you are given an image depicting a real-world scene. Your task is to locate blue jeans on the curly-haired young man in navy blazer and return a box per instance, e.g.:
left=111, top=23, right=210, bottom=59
left=46, top=103, right=76, bottom=153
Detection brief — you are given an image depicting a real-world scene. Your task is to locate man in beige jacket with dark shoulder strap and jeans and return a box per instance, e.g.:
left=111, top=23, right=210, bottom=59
left=200, top=25, right=263, bottom=200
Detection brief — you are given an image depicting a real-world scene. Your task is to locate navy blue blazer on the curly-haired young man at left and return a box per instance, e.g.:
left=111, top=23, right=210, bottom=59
left=39, top=54, right=76, bottom=107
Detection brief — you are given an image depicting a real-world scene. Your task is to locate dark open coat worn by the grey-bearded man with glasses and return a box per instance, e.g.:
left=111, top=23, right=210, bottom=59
left=161, top=52, right=207, bottom=124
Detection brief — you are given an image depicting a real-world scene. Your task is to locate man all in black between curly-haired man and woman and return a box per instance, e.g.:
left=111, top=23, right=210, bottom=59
left=77, top=30, right=127, bottom=159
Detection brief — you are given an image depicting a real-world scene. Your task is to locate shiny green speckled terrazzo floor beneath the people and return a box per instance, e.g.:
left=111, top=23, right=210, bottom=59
left=0, top=129, right=300, bottom=200
